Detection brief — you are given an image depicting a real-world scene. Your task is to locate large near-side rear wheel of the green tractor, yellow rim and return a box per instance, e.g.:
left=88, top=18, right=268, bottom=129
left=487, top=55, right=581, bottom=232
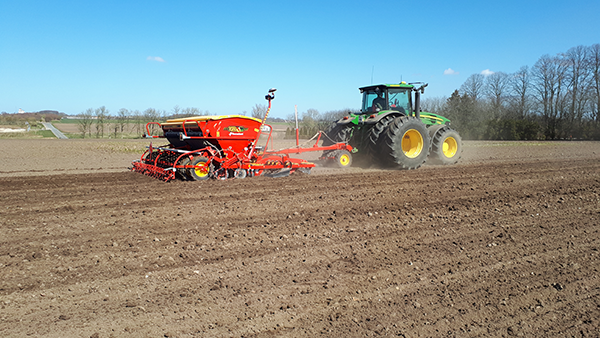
left=378, top=116, right=431, bottom=170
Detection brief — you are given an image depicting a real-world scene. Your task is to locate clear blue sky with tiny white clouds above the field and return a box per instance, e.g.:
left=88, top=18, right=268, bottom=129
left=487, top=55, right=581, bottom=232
left=0, top=0, right=600, bottom=117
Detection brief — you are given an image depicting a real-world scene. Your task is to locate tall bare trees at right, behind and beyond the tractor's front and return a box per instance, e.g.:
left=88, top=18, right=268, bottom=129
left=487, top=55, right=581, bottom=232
left=423, top=44, right=600, bottom=140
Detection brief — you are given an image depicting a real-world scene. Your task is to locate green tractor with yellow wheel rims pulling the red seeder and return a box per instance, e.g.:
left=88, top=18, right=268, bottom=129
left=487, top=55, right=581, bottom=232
left=323, top=82, right=462, bottom=169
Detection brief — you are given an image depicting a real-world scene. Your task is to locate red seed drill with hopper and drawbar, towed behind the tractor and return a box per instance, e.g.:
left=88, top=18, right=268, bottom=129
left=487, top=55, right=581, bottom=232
left=131, top=89, right=352, bottom=181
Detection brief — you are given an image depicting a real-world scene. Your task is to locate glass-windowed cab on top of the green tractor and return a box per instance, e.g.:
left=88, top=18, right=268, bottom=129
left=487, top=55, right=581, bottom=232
left=360, top=82, right=413, bottom=115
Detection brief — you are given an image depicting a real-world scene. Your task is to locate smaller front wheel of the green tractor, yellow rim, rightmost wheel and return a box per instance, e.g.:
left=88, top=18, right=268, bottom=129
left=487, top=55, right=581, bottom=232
left=429, top=126, right=462, bottom=165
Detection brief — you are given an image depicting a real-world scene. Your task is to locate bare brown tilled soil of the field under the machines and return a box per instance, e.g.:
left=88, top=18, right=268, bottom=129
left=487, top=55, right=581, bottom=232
left=0, top=140, right=600, bottom=337
